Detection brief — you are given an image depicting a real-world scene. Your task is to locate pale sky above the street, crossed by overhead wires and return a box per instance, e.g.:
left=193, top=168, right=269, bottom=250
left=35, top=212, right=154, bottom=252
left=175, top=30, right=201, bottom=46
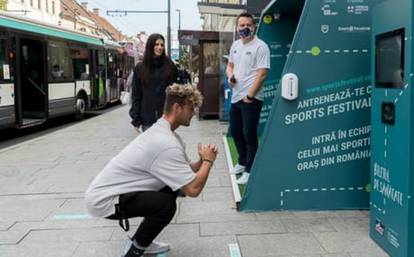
left=77, top=0, right=201, bottom=38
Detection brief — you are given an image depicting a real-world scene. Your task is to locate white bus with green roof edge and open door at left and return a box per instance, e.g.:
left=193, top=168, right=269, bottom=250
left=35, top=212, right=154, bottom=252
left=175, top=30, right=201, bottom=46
left=0, top=15, right=134, bottom=128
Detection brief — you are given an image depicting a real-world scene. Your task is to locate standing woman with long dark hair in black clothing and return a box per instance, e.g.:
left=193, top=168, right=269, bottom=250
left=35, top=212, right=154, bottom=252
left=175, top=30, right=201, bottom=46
left=129, top=34, right=178, bottom=131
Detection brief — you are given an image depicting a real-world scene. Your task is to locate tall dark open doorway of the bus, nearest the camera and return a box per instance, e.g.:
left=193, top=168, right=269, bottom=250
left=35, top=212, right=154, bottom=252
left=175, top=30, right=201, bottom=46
left=17, top=38, right=48, bottom=127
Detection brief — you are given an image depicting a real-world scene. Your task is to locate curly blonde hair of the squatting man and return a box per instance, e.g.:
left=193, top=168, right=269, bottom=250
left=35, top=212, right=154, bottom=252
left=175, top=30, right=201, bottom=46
left=164, top=84, right=203, bottom=113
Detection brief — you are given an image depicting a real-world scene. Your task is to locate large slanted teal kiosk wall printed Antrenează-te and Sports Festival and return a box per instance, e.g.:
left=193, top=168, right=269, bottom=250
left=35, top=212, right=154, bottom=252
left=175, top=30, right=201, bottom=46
left=240, top=0, right=379, bottom=211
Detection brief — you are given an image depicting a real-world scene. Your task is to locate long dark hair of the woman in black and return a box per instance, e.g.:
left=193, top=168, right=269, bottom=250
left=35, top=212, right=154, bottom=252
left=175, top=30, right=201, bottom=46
left=141, top=33, right=174, bottom=85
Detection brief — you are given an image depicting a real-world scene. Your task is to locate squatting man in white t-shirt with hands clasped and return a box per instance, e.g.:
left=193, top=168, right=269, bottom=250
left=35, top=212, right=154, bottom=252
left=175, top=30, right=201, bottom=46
left=85, top=84, right=217, bottom=257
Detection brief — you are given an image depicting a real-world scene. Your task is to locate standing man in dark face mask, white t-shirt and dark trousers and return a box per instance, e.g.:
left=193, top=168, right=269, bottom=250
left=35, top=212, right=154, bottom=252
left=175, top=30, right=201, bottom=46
left=226, top=13, right=270, bottom=184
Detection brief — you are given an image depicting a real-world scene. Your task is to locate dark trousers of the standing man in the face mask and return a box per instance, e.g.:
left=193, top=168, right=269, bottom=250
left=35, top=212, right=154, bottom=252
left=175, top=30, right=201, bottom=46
left=230, top=99, right=263, bottom=172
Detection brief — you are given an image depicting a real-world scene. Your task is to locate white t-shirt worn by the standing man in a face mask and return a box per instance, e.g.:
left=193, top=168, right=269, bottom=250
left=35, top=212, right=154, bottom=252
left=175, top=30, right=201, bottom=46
left=229, top=36, right=270, bottom=103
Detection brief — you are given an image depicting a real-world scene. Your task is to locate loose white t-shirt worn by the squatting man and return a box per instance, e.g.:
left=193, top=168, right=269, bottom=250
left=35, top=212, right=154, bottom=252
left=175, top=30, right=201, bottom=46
left=85, top=118, right=195, bottom=217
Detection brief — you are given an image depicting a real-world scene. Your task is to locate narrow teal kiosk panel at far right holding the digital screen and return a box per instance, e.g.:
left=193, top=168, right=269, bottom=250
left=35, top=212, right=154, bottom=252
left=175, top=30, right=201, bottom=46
left=370, top=0, right=414, bottom=254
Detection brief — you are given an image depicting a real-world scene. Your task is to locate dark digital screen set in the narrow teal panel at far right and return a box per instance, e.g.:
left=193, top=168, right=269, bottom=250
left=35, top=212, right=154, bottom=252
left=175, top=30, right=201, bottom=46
left=375, top=29, right=405, bottom=88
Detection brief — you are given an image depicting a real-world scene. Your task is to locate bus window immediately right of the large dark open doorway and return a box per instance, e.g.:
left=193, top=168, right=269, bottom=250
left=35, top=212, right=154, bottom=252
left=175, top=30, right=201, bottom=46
left=49, top=42, right=73, bottom=81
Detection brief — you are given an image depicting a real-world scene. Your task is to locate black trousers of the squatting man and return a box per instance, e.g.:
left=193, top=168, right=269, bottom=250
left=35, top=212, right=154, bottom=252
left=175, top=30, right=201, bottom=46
left=107, top=187, right=177, bottom=247
